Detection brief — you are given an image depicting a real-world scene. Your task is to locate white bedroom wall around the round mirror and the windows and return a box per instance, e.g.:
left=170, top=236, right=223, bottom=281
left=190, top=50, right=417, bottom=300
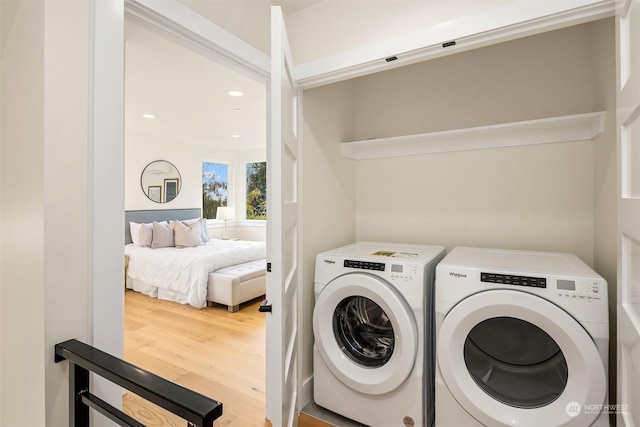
left=124, top=132, right=267, bottom=241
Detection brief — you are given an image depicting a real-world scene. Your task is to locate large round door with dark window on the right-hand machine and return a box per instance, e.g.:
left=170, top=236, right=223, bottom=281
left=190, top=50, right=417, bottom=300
left=437, top=290, right=607, bottom=426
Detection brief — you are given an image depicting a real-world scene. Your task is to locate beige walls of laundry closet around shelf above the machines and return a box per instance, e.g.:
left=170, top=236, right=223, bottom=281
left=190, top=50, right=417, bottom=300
left=300, top=14, right=616, bottom=412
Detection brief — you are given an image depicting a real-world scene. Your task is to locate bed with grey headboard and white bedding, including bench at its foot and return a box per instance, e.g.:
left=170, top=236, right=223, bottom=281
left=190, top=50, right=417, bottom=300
left=125, top=209, right=266, bottom=312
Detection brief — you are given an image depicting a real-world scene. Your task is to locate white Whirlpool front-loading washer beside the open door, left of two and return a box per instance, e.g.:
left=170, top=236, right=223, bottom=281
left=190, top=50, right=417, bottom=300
left=313, top=242, right=445, bottom=427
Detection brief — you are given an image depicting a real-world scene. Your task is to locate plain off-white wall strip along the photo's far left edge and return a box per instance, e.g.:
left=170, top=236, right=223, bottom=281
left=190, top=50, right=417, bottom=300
left=0, top=1, right=47, bottom=426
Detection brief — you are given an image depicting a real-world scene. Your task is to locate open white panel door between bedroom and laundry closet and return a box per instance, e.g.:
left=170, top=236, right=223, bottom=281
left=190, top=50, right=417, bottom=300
left=266, top=7, right=299, bottom=427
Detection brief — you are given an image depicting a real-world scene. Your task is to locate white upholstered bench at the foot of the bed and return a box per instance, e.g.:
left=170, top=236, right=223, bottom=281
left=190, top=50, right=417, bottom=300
left=207, top=259, right=267, bottom=313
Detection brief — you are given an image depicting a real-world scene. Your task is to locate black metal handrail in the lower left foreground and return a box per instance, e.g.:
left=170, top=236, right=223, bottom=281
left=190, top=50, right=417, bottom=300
left=55, top=339, right=222, bottom=427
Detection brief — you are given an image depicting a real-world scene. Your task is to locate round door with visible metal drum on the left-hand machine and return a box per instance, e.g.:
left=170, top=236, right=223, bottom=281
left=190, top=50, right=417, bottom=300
left=313, top=273, right=419, bottom=395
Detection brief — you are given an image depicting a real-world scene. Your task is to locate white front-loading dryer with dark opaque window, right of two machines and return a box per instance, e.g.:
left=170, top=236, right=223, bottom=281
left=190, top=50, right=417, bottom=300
left=435, top=248, right=609, bottom=427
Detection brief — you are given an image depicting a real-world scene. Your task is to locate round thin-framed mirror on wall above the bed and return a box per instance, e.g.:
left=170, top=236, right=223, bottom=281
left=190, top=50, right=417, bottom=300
left=140, top=160, right=182, bottom=203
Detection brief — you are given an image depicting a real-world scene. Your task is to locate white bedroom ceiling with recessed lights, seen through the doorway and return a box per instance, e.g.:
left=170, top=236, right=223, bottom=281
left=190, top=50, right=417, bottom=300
left=125, top=17, right=267, bottom=150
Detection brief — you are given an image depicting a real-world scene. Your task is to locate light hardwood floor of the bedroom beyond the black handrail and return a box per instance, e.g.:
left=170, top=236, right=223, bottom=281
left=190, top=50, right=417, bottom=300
left=123, top=291, right=269, bottom=427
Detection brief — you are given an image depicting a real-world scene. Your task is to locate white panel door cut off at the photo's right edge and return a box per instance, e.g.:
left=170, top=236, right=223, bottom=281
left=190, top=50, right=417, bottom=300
left=616, top=0, right=640, bottom=427
